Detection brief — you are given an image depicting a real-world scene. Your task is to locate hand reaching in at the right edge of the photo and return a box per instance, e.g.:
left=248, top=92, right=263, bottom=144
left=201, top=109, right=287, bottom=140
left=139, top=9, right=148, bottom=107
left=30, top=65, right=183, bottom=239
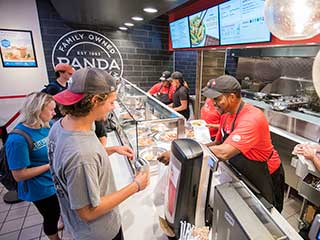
left=292, top=143, right=320, bottom=171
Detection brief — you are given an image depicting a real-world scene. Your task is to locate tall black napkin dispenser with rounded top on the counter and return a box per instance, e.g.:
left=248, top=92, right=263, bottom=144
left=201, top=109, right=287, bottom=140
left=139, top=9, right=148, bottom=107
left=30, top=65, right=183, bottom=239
left=165, top=139, right=203, bottom=237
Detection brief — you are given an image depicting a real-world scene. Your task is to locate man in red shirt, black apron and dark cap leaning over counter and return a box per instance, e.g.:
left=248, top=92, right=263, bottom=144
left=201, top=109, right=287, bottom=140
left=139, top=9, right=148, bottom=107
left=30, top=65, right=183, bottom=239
left=202, top=75, right=285, bottom=212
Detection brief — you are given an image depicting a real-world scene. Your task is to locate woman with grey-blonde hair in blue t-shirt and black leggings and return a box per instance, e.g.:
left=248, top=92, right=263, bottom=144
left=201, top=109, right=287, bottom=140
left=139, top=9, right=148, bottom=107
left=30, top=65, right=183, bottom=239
left=6, top=92, right=60, bottom=240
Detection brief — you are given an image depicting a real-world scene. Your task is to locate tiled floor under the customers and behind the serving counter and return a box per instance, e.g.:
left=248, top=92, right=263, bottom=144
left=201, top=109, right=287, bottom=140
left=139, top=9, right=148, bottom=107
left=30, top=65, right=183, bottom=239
left=0, top=184, right=302, bottom=240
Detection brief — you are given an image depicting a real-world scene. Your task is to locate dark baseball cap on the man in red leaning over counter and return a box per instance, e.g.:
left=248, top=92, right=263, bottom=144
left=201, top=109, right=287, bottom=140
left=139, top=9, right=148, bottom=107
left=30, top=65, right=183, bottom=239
left=202, top=75, right=241, bottom=98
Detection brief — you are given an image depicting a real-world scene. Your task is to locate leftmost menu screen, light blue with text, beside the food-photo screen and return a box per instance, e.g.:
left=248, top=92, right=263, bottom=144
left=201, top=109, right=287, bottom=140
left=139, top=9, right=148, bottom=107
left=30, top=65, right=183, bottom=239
left=170, top=17, right=190, bottom=48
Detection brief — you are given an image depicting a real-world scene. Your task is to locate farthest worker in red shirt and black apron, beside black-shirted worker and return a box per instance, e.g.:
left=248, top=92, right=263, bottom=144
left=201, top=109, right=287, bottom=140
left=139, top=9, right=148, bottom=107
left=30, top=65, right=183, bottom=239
left=148, top=71, right=176, bottom=105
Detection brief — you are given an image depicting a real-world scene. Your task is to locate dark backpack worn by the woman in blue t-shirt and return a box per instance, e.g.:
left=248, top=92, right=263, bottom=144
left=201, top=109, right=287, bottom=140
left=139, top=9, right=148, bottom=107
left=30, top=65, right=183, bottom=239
left=0, top=129, right=33, bottom=191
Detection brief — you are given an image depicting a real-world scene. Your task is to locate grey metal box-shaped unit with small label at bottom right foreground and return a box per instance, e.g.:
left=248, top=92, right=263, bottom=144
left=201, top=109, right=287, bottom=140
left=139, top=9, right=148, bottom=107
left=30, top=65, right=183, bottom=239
left=212, top=181, right=289, bottom=240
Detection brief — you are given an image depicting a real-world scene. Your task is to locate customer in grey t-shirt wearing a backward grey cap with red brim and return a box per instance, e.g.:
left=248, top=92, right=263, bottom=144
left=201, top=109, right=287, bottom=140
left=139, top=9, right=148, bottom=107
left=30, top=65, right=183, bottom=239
left=49, top=68, right=149, bottom=240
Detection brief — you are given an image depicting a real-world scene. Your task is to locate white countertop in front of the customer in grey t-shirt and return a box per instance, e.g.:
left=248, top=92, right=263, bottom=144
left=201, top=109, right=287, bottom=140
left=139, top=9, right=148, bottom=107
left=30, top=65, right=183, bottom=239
left=107, top=132, right=168, bottom=240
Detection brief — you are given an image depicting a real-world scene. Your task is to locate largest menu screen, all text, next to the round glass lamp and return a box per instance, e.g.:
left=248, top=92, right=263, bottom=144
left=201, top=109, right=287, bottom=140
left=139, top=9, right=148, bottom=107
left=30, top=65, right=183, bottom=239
left=219, top=0, right=271, bottom=45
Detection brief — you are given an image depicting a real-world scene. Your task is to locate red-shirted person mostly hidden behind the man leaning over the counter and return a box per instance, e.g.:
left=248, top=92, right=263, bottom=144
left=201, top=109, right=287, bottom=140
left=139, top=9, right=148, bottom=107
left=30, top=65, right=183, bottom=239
left=200, top=98, right=221, bottom=141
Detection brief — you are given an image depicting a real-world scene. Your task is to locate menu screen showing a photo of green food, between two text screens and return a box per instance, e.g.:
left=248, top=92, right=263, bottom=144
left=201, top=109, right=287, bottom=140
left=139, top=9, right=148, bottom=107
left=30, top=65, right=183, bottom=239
left=189, top=6, right=219, bottom=47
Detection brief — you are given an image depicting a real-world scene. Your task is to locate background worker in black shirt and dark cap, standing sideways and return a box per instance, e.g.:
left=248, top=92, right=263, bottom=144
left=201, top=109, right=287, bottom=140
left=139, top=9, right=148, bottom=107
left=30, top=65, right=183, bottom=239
left=171, top=72, right=190, bottom=120
